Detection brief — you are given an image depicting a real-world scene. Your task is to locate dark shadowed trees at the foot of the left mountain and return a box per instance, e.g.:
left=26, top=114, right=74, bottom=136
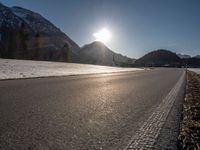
left=0, top=23, right=72, bottom=62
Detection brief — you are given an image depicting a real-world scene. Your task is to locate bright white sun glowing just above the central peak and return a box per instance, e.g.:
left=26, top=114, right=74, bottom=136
left=93, top=28, right=111, bottom=43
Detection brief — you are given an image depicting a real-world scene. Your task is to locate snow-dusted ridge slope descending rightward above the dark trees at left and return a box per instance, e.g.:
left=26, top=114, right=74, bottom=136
left=10, top=7, right=79, bottom=53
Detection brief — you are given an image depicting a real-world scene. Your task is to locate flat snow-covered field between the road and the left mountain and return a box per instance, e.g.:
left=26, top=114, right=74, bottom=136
left=0, top=59, right=143, bottom=79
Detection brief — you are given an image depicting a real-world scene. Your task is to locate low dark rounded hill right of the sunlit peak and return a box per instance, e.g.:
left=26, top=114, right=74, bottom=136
left=134, top=49, right=182, bottom=67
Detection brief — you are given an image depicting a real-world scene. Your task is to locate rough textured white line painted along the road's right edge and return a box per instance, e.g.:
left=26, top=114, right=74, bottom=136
left=124, top=72, right=185, bottom=150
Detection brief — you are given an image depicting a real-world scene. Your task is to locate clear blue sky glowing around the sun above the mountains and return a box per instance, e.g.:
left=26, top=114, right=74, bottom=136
left=0, top=0, right=200, bottom=58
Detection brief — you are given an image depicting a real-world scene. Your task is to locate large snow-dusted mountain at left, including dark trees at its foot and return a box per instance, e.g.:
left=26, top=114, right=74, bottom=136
left=0, top=3, right=80, bottom=61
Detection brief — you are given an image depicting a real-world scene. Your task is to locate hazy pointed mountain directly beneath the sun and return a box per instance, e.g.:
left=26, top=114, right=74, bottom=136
left=79, top=41, right=134, bottom=66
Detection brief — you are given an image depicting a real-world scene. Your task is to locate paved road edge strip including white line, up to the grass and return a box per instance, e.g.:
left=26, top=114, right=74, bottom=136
left=125, top=73, right=185, bottom=150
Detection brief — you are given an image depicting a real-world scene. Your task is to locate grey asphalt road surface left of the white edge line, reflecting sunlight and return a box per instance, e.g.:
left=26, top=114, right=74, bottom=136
left=0, top=69, right=183, bottom=150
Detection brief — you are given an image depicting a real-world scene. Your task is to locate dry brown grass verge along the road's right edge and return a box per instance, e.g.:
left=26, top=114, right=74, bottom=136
left=179, top=71, right=200, bottom=150
